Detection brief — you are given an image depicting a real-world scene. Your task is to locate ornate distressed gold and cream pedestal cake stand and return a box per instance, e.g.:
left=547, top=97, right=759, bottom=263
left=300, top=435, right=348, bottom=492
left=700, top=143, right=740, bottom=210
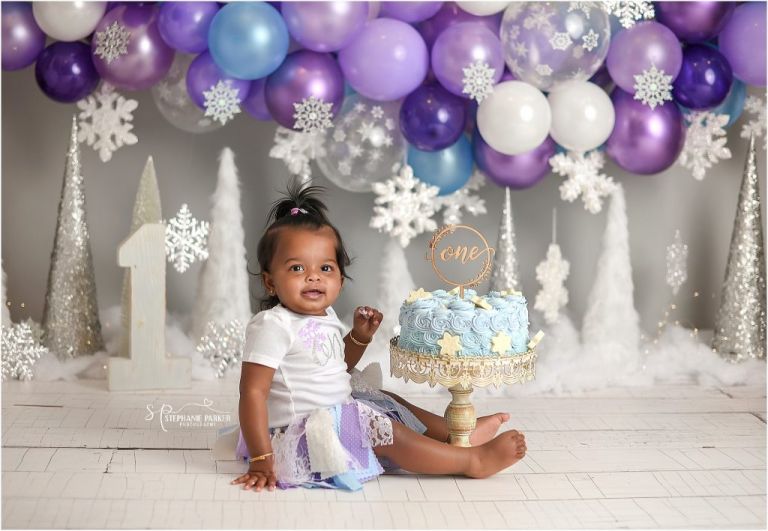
left=389, top=337, right=536, bottom=447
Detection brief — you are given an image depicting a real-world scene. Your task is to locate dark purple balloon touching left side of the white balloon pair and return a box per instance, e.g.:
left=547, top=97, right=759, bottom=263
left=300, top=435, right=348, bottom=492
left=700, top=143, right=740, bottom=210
left=400, top=84, right=466, bottom=151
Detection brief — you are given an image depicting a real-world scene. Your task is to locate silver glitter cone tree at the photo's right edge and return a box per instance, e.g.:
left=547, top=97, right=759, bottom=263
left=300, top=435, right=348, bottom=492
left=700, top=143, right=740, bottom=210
left=712, top=134, right=766, bottom=361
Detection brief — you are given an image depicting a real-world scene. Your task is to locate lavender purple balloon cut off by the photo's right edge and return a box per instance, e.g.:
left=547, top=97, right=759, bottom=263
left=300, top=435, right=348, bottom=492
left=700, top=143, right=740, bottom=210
left=718, top=2, right=766, bottom=87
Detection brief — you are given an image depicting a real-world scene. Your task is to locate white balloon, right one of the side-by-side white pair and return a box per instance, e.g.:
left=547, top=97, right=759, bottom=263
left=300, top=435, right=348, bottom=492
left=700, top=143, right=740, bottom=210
left=548, top=80, right=616, bottom=151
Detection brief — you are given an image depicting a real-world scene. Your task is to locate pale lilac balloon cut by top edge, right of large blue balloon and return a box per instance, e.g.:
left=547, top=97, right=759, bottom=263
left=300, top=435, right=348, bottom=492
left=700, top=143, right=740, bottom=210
left=282, top=2, right=368, bottom=52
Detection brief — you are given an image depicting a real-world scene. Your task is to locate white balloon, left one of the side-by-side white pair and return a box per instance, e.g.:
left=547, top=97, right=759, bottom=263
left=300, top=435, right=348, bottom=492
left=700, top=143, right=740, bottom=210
left=477, top=81, right=552, bottom=155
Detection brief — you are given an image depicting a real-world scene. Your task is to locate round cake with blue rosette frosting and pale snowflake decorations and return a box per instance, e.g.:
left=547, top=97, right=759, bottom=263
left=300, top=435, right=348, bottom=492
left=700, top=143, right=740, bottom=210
left=397, top=289, right=528, bottom=357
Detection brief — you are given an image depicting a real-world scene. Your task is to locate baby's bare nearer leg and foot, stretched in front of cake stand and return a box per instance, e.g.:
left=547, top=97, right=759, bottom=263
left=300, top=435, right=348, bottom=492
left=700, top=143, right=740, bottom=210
left=373, top=422, right=526, bottom=478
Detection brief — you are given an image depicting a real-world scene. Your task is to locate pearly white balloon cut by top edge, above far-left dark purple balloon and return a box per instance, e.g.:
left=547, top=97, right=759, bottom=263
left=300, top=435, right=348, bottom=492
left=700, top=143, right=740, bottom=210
left=32, top=2, right=107, bottom=41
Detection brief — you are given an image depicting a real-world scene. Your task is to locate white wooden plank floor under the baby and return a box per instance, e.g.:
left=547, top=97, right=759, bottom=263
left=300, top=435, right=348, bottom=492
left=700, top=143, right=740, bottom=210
left=2, top=375, right=766, bottom=529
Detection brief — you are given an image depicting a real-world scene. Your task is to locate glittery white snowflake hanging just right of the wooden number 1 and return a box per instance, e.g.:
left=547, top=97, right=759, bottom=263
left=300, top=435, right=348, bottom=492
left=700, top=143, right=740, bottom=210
left=165, top=203, right=209, bottom=273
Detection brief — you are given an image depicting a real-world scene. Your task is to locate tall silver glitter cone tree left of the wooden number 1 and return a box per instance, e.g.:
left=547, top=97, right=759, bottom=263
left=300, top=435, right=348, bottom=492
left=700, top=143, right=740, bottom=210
left=42, top=116, right=104, bottom=359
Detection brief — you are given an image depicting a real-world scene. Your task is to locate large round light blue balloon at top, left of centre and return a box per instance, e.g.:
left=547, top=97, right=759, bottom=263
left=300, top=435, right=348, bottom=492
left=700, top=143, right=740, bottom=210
left=208, top=2, right=289, bottom=79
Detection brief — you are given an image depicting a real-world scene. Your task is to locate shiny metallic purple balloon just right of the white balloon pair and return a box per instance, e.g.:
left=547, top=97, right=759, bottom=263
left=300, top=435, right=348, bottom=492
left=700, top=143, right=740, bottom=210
left=606, top=88, right=685, bottom=175
